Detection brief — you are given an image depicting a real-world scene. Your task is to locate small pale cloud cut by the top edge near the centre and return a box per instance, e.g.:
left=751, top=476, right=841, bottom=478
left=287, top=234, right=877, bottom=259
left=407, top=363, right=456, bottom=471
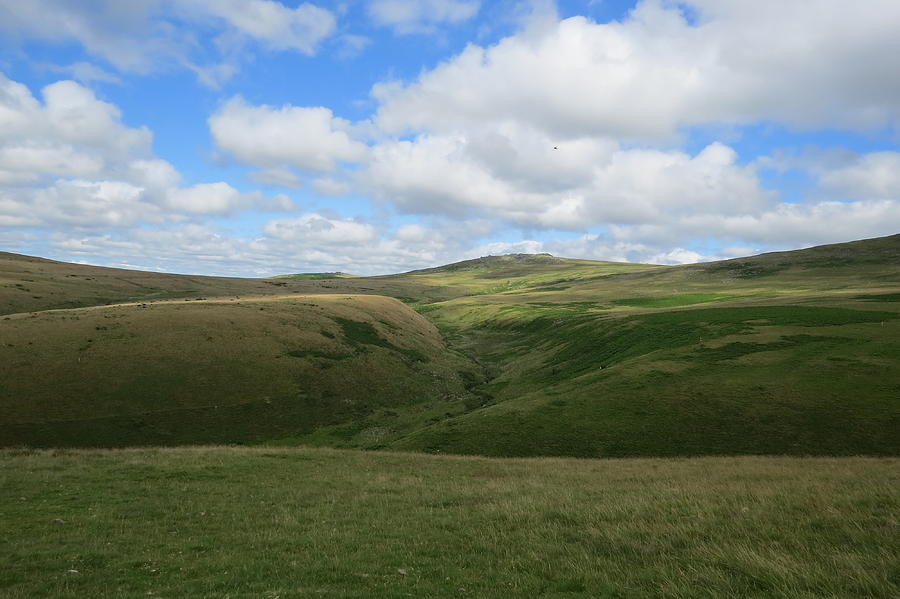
left=368, top=0, right=481, bottom=34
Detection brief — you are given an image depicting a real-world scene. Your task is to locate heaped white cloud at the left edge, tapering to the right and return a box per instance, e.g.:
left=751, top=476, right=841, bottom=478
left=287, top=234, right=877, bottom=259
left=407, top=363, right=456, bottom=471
left=0, top=74, right=290, bottom=228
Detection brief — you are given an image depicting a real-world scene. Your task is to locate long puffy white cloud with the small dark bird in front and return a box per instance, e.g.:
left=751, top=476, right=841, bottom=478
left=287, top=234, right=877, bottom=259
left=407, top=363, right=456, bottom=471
left=360, top=132, right=768, bottom=230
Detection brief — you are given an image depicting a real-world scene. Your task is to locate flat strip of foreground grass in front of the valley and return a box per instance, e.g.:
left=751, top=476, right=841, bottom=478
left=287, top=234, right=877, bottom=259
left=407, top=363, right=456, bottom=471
left=0, top=448, right=900, bottom=598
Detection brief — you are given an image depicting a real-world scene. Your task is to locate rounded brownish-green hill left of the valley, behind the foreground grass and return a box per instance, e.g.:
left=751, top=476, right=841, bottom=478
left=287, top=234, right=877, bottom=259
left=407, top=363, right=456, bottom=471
left=0, top=295, right=478, bottom=446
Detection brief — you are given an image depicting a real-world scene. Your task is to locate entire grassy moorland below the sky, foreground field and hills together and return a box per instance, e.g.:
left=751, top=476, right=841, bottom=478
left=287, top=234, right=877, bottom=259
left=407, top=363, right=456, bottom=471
left=0, top=235, right=900, bottom=598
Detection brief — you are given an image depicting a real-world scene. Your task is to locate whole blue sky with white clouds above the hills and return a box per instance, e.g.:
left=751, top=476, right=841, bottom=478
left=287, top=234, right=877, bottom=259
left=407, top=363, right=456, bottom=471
left=0, top=0, right=900, bottom=277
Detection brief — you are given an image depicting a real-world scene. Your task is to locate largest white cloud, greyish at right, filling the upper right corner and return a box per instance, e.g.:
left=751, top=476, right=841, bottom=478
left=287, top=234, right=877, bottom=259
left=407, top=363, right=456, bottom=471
left=373, top=0, right=900, bottom=141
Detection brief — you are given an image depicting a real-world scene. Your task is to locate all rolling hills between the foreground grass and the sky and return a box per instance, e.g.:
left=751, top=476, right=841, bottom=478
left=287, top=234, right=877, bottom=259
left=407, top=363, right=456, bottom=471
left=0, top=236, right=900, bottom=457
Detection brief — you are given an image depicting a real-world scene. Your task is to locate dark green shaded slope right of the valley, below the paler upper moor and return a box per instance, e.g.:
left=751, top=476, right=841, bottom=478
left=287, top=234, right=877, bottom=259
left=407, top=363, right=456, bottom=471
left=400, top=300, right=900, bottom=457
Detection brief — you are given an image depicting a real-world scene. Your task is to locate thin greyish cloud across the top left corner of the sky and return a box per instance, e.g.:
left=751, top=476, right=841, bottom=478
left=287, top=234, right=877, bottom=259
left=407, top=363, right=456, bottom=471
left=0, top=0, right=336, bottom=86
